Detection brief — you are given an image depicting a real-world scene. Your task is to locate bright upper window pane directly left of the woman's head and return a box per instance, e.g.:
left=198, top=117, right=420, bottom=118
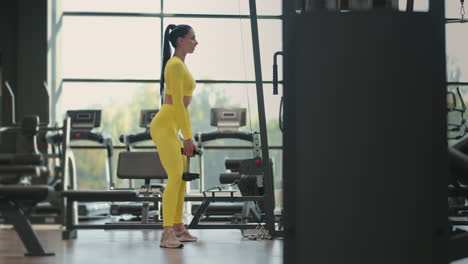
left=62, top=16, right=161, bottom=79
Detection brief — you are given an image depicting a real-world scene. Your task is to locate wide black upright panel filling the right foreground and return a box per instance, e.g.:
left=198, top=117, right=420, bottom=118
left=283, top=6, right=448, bottom=264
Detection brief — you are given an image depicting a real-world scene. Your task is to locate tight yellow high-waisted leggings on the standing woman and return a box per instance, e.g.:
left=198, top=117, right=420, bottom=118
left=150, top=104, right=187, bottom=226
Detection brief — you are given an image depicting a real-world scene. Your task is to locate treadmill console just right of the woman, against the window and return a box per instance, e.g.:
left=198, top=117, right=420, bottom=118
left=211, top=108, right=246, bottom=131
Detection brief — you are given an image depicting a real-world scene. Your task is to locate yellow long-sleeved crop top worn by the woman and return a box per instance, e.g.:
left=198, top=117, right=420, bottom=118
left=164, top=56, right=196, bottom=140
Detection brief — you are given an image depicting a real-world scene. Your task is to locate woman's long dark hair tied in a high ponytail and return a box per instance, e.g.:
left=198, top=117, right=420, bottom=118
left=159, top=24, right=192, bottom=96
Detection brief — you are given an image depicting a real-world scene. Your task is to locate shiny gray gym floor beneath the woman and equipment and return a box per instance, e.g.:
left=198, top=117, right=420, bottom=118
left=0, top=226, right=283, bottom=264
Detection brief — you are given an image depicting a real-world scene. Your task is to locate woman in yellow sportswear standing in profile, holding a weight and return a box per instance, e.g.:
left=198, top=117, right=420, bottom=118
left=150, top=24, right=198, bottom=248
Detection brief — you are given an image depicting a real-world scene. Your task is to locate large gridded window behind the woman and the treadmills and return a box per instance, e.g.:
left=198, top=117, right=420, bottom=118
left=53, top=0, right=282, bottom=204
